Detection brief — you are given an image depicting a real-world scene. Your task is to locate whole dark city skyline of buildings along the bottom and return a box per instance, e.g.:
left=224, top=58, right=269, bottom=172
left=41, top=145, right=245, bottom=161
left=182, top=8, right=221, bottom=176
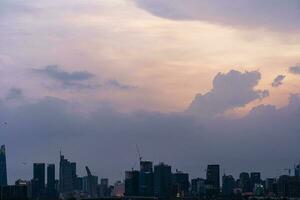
left=0, top=145, right=300, bottom=200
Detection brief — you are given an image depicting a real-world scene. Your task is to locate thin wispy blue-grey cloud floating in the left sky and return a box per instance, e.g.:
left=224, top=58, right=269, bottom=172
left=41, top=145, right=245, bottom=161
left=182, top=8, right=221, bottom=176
left=33, top=65, right=100, bottom=89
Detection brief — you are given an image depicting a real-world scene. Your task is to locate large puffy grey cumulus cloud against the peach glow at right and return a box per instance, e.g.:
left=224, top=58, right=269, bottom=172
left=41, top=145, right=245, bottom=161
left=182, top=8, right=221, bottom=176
left=187, top=70, right=269, bottom=117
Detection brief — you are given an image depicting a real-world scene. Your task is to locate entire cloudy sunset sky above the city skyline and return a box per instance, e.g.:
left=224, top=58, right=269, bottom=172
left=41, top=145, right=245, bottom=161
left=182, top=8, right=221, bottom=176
left=0, top=0, right=300, bottom=183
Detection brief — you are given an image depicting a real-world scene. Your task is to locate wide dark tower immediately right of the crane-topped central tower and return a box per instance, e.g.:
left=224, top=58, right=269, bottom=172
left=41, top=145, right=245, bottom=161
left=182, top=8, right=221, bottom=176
left=154, top=163, right=172, bottom=199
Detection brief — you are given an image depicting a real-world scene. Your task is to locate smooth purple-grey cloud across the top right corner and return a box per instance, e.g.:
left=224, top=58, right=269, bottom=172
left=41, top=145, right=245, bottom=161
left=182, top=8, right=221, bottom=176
left=134, top=0, right=300, bottom=31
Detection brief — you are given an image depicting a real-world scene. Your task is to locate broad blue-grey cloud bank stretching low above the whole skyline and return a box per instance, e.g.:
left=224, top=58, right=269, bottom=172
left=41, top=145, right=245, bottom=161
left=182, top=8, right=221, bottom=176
left=0, top=90, right=300, bottom=182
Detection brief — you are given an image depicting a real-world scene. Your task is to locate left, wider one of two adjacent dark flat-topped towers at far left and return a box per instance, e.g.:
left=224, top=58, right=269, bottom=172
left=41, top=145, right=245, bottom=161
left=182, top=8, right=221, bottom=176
left=32, top=163, right=45, bottom=197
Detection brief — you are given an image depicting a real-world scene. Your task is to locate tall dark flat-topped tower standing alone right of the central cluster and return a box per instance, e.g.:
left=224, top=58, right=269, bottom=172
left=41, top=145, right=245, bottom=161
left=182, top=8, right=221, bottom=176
left=206, top=165, right=220, bottom=195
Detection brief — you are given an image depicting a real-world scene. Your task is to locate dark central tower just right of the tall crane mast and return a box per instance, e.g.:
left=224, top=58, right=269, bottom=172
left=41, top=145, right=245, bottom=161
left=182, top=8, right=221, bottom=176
left=139, top=161, right=154, bottom=197
